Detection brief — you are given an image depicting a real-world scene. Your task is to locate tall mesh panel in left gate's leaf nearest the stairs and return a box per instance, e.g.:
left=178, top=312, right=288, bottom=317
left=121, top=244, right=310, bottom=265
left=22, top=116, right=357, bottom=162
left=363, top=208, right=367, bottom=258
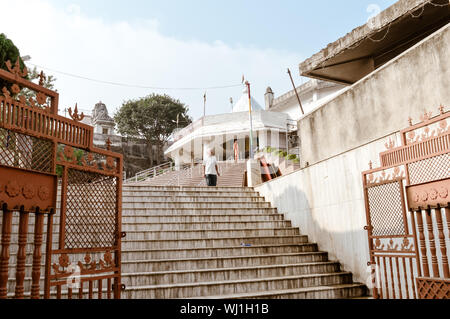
left=65, top=169, right=117, bottom=249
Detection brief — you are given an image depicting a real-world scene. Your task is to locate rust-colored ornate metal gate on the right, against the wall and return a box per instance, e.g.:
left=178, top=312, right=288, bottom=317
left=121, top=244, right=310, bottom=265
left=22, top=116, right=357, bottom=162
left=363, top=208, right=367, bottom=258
left=363, top=106, right=450, bottom=299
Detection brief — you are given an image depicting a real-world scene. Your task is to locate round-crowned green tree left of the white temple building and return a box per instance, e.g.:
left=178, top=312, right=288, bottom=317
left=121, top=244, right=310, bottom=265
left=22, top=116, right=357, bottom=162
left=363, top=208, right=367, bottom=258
left=114, top=94, right=192, bottom=165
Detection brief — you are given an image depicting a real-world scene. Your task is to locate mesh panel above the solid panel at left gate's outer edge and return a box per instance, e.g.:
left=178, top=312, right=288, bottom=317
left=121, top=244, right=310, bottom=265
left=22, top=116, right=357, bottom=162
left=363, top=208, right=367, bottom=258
left=0, top=128, right=53, bottom=173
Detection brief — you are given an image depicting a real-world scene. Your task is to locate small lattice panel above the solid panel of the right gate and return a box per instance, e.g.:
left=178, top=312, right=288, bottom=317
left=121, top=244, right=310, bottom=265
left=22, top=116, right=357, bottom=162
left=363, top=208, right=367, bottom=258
left=409, top=153, right=450, bottom=185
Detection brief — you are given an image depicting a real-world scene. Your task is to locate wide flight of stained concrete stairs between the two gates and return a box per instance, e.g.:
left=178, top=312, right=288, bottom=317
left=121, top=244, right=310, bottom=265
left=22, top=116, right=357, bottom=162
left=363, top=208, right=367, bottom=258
left=122, top=183, right=366, bottom=299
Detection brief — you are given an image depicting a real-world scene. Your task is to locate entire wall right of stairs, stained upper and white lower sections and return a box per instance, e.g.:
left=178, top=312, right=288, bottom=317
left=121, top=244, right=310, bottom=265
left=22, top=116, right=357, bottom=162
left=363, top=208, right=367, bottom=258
left=256, top=25, right=450, bottom=283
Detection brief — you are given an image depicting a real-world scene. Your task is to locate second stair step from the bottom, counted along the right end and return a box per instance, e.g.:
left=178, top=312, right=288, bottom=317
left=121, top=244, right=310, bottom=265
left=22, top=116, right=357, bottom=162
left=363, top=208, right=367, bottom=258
left=122, top=272, right=352, bottom=299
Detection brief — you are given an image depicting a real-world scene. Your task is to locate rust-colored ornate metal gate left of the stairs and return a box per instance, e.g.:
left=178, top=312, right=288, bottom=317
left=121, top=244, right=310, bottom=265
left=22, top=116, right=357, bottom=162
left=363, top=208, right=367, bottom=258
left=0, top=62, right=124, bottom=299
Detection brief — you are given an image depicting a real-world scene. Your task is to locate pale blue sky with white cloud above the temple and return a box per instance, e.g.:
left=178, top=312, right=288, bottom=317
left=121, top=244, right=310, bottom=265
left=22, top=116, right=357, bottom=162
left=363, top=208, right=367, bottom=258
left=0, top=0, right=396, bottom=119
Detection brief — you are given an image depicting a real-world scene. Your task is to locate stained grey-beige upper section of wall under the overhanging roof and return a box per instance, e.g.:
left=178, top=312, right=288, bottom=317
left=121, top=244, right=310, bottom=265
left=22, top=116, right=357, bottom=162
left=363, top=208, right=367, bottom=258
left=299, top=24, right=450, bottom=167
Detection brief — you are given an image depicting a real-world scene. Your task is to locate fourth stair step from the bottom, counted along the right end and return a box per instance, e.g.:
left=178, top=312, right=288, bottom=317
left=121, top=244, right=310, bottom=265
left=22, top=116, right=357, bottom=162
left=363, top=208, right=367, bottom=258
left=122, top=252, right=328, bottom=273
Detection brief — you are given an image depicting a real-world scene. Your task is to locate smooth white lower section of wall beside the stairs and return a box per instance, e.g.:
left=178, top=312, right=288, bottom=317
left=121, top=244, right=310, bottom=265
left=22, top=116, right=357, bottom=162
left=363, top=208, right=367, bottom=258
left=255, top=134, right=400, bottom=283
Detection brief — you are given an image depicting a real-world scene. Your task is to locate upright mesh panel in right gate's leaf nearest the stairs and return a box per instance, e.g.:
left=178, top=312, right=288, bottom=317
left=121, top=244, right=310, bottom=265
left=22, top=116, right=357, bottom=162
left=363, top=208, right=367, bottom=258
left=367, top=181, right=406, bottom=236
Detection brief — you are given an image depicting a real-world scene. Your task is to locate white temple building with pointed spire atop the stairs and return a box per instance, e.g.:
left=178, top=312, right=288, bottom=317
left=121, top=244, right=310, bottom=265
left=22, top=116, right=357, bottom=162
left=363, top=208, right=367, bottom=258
left=165, top=80, right=345, bottom=166
